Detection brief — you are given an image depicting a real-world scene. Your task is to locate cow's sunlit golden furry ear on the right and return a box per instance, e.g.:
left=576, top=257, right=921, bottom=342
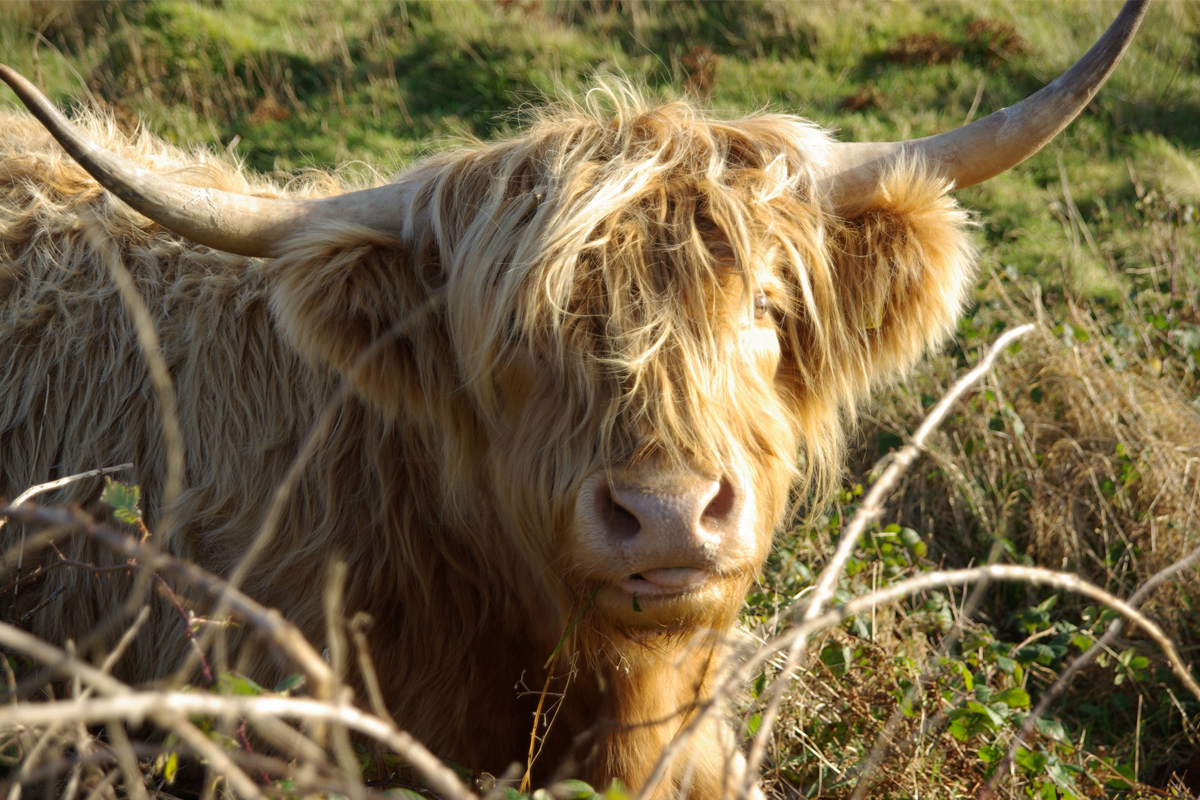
left=785, top=163, right=976, bottom=413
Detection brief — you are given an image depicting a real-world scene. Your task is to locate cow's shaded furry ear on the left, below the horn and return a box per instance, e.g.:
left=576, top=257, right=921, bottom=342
left=268, top=223, right=452, bottom=415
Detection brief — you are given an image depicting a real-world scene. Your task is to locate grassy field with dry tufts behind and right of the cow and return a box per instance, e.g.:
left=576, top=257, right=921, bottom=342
left=0, top=0, right=1200, bottom=800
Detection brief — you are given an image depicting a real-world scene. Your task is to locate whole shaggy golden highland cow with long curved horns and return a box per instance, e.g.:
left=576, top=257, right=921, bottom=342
left=0, top=4, right=1144, bottom=798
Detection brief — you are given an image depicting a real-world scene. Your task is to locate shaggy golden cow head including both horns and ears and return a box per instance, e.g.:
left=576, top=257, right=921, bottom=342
left=0, top=4, right=1144, bottom=631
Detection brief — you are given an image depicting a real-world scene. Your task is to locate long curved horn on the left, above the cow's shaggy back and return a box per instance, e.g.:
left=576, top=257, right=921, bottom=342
left=0, top=65, right=403, bottom=257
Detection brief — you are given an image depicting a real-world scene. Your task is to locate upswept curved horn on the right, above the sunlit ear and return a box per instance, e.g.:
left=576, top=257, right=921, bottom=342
left=823, top=0, right=1148, bottom=206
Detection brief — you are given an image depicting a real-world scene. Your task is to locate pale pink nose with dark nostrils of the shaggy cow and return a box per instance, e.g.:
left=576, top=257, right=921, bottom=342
left=595, top=476, right=740, bottom=554
